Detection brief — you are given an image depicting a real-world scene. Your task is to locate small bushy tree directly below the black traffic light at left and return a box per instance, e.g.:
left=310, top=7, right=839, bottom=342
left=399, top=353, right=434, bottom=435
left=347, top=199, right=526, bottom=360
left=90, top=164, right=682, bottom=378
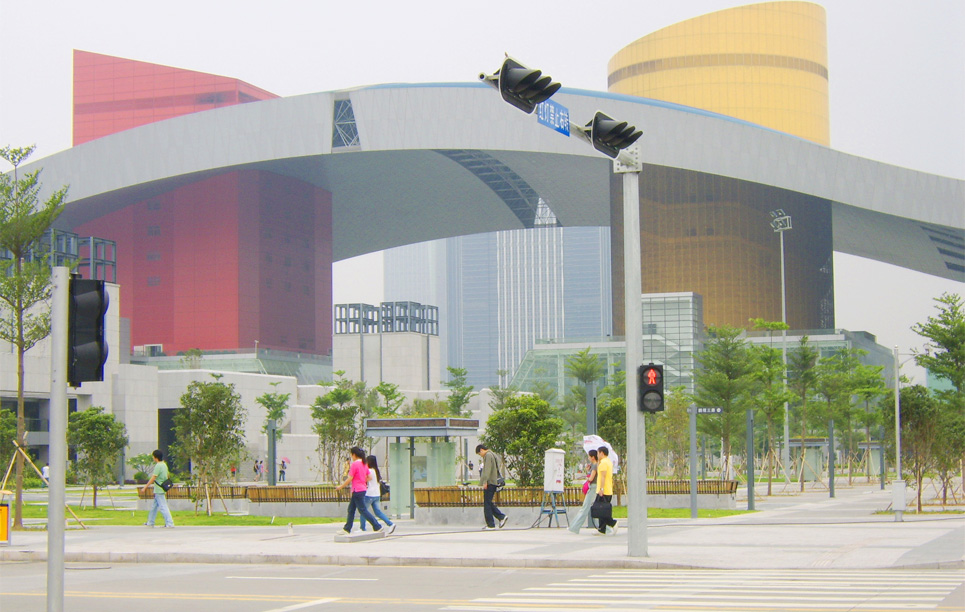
left=67, top=406, right=127, bottom=508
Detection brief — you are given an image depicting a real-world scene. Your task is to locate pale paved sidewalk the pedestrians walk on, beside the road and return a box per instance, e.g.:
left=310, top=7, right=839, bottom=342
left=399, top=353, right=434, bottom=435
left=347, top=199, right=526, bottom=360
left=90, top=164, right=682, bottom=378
left=0, top=486, right=965, bottom=569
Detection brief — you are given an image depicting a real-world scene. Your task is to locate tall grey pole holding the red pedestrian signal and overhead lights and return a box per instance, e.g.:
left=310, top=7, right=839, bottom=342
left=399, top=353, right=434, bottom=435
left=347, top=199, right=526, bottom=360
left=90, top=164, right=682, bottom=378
left=613, top=148, right=647, bottom=557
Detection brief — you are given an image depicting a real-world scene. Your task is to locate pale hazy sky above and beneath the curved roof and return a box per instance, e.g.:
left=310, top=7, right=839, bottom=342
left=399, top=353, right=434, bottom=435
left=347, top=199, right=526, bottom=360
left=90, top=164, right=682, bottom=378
left=0, top=0, right=965, bottom=383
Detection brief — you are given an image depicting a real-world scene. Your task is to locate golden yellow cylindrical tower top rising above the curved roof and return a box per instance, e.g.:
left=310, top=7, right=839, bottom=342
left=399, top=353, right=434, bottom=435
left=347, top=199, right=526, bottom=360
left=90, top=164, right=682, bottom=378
left=607, top=2, right=830, bottom=146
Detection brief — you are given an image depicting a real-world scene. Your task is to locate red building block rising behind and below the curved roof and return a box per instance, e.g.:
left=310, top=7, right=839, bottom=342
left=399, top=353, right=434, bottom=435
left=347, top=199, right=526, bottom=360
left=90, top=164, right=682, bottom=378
left=73, top=52, right=332, bottom=355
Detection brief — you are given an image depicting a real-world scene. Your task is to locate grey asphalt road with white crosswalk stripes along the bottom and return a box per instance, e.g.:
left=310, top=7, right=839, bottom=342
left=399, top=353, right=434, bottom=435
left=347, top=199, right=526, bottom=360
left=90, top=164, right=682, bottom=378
left=0, top=563, right=965, bottom=612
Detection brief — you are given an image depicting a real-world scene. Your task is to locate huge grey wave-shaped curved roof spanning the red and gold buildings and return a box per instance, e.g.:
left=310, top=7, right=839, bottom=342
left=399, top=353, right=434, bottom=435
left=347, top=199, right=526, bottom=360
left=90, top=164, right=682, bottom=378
left=22, top=84, right=965, bottom=281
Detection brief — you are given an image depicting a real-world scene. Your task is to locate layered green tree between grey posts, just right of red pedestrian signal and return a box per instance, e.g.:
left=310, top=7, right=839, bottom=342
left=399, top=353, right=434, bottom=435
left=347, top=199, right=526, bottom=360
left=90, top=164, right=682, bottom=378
left=694, top=327, right=754, bottom=478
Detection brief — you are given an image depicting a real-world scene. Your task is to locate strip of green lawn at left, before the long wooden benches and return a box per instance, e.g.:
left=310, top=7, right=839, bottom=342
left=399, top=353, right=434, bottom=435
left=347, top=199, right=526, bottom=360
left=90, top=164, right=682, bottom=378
left=17, top=504, right=345, bottom=527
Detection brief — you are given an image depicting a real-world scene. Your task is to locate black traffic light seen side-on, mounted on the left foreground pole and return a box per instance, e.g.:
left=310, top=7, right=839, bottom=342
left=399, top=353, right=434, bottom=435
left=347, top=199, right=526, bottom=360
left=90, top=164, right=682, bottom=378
left=67, top=277, right=110, bottom=387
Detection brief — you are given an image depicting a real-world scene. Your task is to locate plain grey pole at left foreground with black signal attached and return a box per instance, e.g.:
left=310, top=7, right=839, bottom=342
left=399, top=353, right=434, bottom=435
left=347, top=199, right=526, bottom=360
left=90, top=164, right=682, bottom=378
left=47, top=266, right=70, bottom=612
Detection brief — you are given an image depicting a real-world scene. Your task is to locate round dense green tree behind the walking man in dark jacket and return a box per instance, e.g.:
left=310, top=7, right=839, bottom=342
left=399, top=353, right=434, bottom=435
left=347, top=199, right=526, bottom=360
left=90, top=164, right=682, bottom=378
left=480, top=395, right=563, bottom=487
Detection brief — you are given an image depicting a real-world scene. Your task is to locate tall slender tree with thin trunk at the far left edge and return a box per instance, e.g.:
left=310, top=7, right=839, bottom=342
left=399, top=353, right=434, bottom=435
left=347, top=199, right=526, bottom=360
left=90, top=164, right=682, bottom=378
left=0, top=146, right=67, bottom=529
